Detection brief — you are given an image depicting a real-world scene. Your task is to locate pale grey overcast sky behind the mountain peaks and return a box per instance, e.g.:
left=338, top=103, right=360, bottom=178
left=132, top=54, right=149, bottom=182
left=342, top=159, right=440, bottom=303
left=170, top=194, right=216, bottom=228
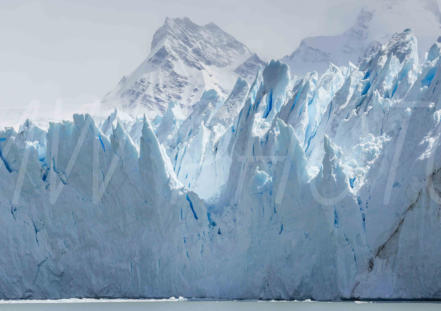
left=0, top=0, right=438, bottom=124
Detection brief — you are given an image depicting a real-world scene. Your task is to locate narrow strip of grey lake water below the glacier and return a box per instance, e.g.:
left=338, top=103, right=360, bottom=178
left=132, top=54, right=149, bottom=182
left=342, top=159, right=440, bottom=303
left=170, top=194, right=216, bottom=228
left=0, top=300, right=441, bottom=311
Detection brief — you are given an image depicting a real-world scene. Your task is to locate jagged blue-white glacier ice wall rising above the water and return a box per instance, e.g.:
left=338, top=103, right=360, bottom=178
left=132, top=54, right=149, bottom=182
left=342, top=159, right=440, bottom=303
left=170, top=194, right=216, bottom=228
left=4, top=26, right=441, bottom=299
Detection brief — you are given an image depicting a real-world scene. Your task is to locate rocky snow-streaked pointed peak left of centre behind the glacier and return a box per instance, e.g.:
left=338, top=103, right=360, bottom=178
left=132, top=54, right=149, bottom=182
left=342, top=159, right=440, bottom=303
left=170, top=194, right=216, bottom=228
left=104, top=18, right=264, bottom=119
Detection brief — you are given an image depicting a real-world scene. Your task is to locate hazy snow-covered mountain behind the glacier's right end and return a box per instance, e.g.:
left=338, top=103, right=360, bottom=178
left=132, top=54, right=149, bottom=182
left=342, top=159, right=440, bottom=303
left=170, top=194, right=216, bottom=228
left=282, top=0, right=441, bottom=76
